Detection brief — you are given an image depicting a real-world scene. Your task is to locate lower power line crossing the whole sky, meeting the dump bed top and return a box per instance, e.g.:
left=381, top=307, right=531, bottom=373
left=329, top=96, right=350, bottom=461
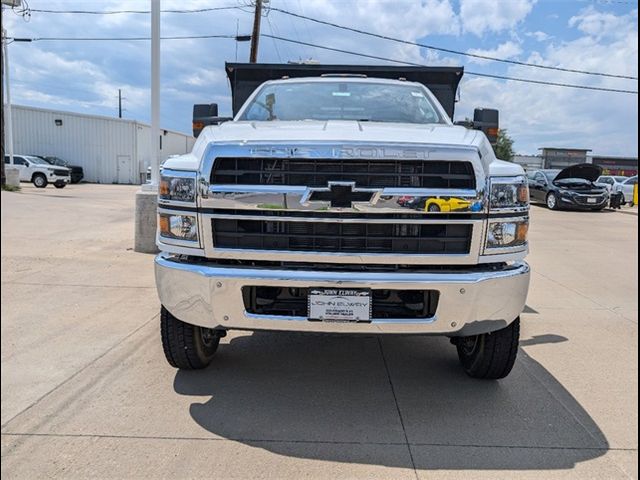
left=9, top=33, right=638, bottom=95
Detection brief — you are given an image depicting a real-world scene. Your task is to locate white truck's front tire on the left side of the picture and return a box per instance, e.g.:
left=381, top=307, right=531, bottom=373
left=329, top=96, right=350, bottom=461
left=160, top=307, right=220, bottom=370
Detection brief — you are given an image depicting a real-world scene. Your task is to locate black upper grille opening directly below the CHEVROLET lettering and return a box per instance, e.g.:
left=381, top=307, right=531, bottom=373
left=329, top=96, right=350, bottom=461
left=211, top=157, right=476, bottom=189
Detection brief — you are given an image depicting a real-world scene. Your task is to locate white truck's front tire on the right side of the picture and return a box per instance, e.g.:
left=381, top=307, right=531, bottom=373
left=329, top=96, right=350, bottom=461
left=456, top=317, right=520, bottom=380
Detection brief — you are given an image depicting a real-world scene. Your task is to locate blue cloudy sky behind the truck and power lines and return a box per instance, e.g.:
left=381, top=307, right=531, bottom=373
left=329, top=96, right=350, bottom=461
left=3, top=0, right=638, bottom=156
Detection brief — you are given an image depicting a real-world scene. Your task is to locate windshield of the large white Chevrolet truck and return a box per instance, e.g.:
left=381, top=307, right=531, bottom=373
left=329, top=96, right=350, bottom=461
left=239, top=80, right=445, bottom=124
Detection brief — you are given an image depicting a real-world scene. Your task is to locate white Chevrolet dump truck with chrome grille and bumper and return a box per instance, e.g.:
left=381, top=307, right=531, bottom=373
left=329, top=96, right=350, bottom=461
left=155, top=64, right=529, bottom=379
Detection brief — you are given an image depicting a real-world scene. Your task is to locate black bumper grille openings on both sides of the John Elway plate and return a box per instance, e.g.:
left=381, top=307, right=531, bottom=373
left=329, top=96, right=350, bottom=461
left=242, top=286, right=440, bottom=320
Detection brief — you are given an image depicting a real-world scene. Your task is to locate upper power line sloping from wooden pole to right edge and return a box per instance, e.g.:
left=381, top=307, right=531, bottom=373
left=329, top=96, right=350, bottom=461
left=271, top=7, right=638, bottom=80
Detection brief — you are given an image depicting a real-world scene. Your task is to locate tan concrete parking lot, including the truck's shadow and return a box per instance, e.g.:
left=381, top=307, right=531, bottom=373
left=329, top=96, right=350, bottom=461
left=2, top=184, right=638, bottom=479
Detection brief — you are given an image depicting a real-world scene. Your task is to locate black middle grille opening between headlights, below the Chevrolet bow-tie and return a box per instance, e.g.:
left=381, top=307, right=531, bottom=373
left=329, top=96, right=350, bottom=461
left=211, top=218, right=472, bottom=254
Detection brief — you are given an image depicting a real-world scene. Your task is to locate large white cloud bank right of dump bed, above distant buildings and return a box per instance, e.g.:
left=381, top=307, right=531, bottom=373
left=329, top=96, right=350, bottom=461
left=459, top=7, right=638, bottom=155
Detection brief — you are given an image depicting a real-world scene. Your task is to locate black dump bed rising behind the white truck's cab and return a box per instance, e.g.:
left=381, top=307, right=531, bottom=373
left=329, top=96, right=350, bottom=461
left=225, top=63, right=464, bottom=119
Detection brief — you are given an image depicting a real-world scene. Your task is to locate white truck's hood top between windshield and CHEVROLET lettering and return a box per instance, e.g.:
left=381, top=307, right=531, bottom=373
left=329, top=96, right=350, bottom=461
left=212, top=120, right=478, bottom=147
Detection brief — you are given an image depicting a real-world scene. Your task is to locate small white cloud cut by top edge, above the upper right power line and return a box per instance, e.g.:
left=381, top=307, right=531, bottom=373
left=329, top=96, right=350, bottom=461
left=460, top=0, right=536, bottom=36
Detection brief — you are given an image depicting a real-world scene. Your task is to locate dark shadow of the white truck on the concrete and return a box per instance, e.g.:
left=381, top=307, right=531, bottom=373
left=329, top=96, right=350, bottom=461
left=174, top=332, right=608, bottom=470
